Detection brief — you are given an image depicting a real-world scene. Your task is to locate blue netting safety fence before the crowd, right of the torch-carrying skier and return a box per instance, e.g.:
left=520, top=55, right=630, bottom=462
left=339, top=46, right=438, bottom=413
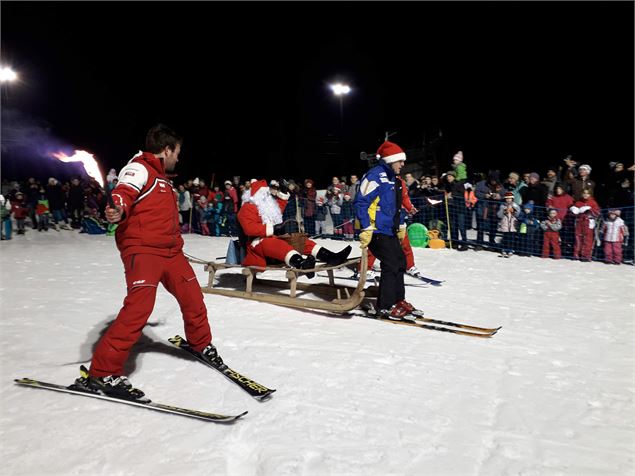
left=182, top=193, right=634, bottom=264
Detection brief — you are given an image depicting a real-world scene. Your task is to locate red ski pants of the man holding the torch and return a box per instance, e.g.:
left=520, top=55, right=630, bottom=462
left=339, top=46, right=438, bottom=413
left=90, top=253, right=212, bottom=377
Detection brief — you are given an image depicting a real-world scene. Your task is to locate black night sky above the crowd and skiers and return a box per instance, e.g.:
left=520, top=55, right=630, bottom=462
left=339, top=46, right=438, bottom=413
left=0, top=1, right=634, bottom=186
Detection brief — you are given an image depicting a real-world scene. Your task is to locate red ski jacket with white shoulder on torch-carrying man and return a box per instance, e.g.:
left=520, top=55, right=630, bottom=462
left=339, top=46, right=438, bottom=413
left=112, top=152, right=183, bottom=258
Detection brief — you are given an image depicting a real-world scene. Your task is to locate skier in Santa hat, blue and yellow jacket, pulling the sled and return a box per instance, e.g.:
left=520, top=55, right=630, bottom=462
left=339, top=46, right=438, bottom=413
left=354, top=141, right=415, bottom=319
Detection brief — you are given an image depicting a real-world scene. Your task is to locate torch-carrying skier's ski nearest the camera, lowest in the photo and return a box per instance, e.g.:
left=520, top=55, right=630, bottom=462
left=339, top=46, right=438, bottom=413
left=15, top=378, right=247, bottom=423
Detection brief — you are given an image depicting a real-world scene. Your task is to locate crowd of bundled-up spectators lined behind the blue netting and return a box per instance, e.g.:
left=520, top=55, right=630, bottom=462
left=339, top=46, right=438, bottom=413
left=2, top=155, right=635, bottom=263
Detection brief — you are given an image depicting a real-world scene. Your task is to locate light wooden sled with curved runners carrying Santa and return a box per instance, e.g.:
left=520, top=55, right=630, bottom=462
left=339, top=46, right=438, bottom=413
left=189, top=249, right=368, bottom=314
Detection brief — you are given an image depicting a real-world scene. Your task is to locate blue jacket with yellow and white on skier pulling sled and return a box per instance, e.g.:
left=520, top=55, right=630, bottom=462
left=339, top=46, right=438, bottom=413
left=354, top=162, right=404, bottom=236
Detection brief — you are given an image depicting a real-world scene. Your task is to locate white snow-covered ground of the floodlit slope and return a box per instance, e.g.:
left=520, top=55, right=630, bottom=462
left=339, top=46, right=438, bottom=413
left=0, top=231, right=635, bottom=476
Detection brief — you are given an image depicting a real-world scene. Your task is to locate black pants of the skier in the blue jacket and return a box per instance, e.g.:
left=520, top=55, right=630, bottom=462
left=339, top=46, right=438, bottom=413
left=368, top=233, right=406, bottom=309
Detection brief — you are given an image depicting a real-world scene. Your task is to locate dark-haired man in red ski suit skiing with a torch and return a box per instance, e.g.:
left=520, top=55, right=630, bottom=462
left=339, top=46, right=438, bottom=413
left=75, top=124, right=222, bottom=401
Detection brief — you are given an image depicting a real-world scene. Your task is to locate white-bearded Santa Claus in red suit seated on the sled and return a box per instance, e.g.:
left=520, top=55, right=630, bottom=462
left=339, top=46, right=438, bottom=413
left=238, top=180, right=351, bottom=278
